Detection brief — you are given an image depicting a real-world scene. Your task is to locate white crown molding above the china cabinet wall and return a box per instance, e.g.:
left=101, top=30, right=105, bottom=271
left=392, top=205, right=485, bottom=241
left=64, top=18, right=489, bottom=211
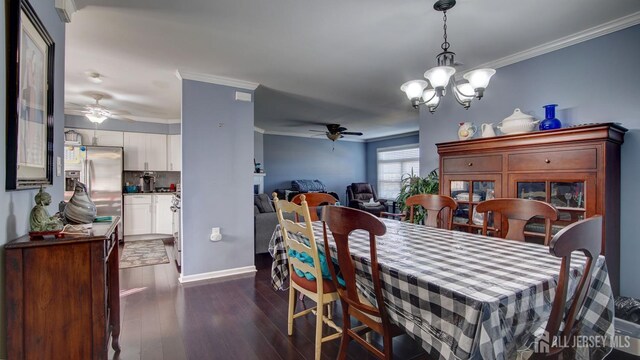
left=470, top=11, right=640, bottom=70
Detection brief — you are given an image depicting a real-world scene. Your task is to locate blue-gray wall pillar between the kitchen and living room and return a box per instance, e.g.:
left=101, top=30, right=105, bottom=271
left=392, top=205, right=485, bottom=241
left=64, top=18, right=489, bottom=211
left=181, top=80, right=254, bottom=275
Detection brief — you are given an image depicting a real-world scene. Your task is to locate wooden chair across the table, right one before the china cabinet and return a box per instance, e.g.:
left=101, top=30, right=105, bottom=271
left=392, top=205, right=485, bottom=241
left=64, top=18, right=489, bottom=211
left=475, top=198, right=558, bottom=245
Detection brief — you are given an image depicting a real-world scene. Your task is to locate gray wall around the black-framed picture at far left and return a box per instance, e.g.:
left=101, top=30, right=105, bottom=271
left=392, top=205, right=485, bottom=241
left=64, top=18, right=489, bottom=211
left=0, top=0, right=65, bottom=358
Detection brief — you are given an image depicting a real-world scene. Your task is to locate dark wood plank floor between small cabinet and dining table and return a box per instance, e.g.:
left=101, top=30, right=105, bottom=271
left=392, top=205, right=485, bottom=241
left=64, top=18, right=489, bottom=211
left=110, top=245, right=427, bottom=360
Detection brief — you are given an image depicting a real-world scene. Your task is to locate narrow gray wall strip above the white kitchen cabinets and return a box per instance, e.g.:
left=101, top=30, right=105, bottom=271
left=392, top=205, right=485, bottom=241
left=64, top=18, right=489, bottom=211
left=64, top=115, right=180, bottom=135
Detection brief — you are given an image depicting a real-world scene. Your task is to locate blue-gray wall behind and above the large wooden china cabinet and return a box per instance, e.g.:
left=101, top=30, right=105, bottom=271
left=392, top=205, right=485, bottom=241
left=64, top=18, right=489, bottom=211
left=420, top=26, right=640, bottom=298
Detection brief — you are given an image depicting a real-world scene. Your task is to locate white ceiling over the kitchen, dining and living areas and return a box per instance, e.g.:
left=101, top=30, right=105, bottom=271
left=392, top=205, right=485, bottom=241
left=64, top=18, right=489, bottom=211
left=65, top=0, right=640, bottom=138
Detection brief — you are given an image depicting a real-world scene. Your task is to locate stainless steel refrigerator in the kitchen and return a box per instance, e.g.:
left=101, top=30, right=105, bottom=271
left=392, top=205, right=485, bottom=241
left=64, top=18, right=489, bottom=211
left=64, top=144, right=123, bottom=239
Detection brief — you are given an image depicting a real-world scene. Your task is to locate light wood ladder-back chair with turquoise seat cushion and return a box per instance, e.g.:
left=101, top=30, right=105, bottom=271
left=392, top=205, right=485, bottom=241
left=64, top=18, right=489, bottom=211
left=273, top=193, right=342, bottom=360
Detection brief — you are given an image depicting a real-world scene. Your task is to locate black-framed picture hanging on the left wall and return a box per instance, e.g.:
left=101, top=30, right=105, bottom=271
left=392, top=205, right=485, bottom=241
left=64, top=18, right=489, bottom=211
left=5, top=0, right=55, bottom=190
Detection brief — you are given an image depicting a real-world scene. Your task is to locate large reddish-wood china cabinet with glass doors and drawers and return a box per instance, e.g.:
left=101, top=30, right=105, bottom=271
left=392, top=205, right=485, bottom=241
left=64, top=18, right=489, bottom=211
left=437, top=123, right=627, bottom=294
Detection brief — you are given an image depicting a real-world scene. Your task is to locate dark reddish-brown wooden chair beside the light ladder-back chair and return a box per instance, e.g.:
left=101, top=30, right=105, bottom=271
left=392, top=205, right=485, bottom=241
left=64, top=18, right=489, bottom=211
left=322, top=206, right=403, bottom=359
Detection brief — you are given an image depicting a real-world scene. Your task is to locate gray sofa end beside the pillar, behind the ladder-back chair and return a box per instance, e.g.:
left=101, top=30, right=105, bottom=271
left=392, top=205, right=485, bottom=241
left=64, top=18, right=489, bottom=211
left=253, top=194, right=294, bottom=254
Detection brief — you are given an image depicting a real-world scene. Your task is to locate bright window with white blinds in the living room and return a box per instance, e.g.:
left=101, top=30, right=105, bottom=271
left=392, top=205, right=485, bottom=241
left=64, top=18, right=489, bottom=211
left=378, top=144, right=420, bottom=199
